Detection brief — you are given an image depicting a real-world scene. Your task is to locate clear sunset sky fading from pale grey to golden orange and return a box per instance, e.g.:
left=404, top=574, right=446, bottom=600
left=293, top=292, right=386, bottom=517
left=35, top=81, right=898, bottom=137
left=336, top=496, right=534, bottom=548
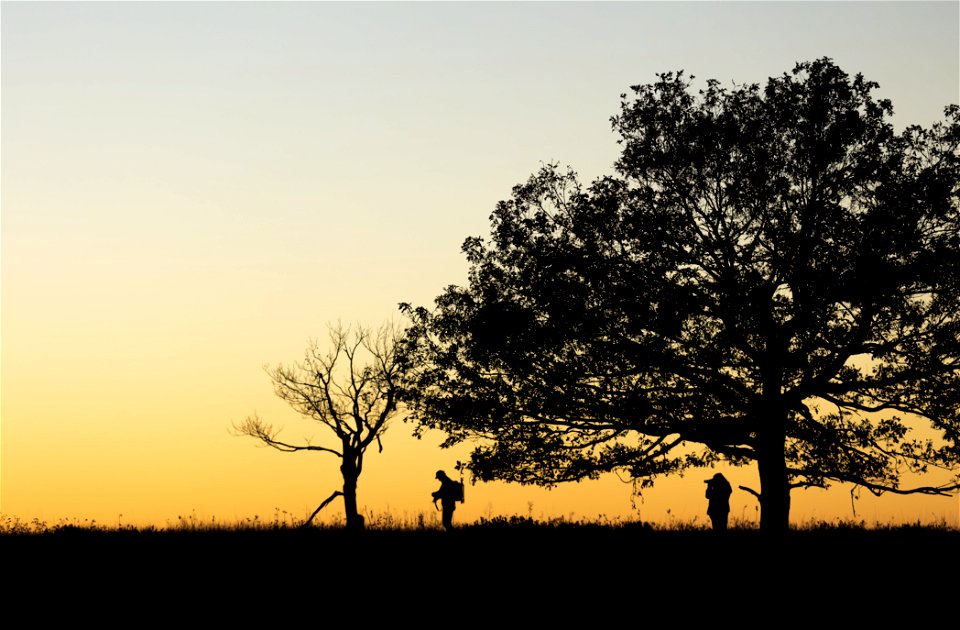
left=0, top=1, right=960, bottom=526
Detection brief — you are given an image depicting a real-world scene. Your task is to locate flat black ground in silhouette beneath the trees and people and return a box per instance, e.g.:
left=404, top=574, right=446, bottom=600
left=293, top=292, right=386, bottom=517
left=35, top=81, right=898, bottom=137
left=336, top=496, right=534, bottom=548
left=0, top=525, right=960, bottom=628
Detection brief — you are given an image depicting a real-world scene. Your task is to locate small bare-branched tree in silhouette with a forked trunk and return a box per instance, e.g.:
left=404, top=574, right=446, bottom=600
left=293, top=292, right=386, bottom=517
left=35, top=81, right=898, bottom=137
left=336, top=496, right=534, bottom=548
left=242, top=325, right=401, bottom=529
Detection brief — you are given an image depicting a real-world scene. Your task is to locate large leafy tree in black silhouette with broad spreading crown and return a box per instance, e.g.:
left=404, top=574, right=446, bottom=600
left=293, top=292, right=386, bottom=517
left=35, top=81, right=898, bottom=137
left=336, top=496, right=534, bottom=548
left=402, top=59, right=960, bottom=531
